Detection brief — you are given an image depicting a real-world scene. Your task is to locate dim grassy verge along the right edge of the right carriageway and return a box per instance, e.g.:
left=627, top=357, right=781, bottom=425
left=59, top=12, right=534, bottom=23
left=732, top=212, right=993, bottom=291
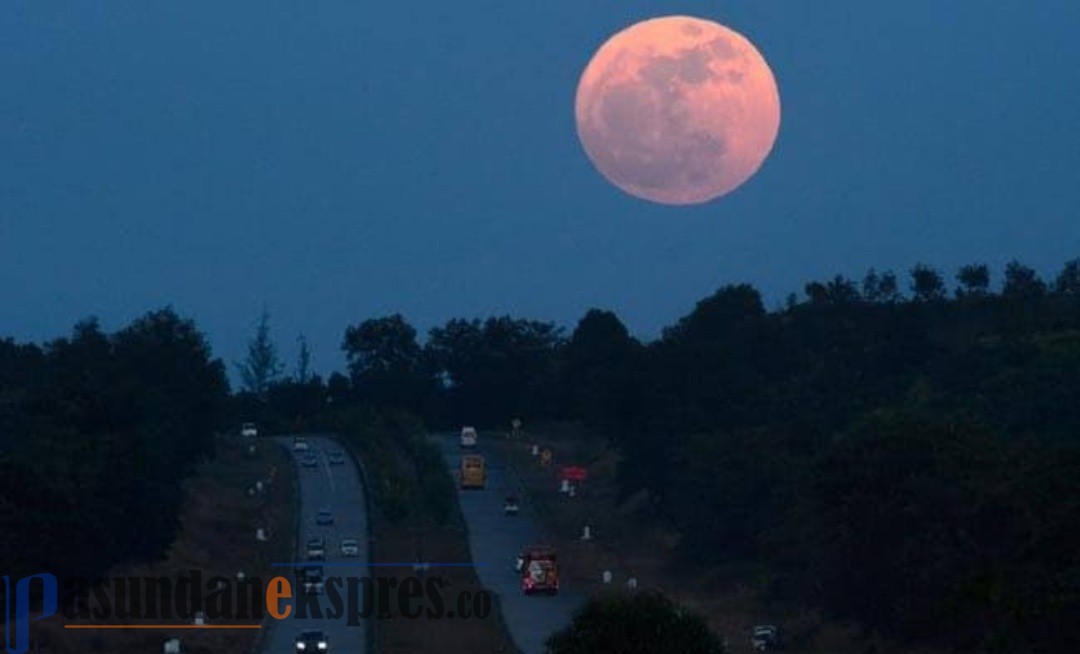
left=486, top=426, right=902, bottom=654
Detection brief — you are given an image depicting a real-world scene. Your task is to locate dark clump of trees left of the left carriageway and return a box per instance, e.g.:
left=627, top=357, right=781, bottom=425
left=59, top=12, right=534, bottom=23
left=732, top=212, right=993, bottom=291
left=0, top=309, right=229, bottom=601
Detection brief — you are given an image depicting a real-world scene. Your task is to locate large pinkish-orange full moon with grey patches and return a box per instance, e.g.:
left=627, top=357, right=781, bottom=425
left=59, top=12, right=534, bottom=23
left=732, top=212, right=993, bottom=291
left=575, top=16, right=780, bottom=205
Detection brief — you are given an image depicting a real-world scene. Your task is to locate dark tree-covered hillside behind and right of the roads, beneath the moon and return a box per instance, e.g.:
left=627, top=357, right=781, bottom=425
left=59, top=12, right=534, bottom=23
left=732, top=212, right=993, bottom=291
left=265, top=261, right=1080, bottom=652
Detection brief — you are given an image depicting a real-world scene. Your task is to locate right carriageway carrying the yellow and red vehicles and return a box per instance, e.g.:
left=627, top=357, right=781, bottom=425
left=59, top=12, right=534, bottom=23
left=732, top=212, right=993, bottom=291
left=431, top=434, right=585, bottom=654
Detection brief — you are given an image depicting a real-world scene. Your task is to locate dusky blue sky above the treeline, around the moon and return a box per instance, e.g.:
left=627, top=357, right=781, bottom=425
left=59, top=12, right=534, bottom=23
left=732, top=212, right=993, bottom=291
left=0, top=0, right=1080, bottom=379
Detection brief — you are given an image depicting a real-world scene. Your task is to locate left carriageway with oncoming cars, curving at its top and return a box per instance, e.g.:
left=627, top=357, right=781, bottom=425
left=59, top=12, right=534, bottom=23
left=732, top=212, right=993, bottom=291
left=260, top=436, right=370, bottom=654
